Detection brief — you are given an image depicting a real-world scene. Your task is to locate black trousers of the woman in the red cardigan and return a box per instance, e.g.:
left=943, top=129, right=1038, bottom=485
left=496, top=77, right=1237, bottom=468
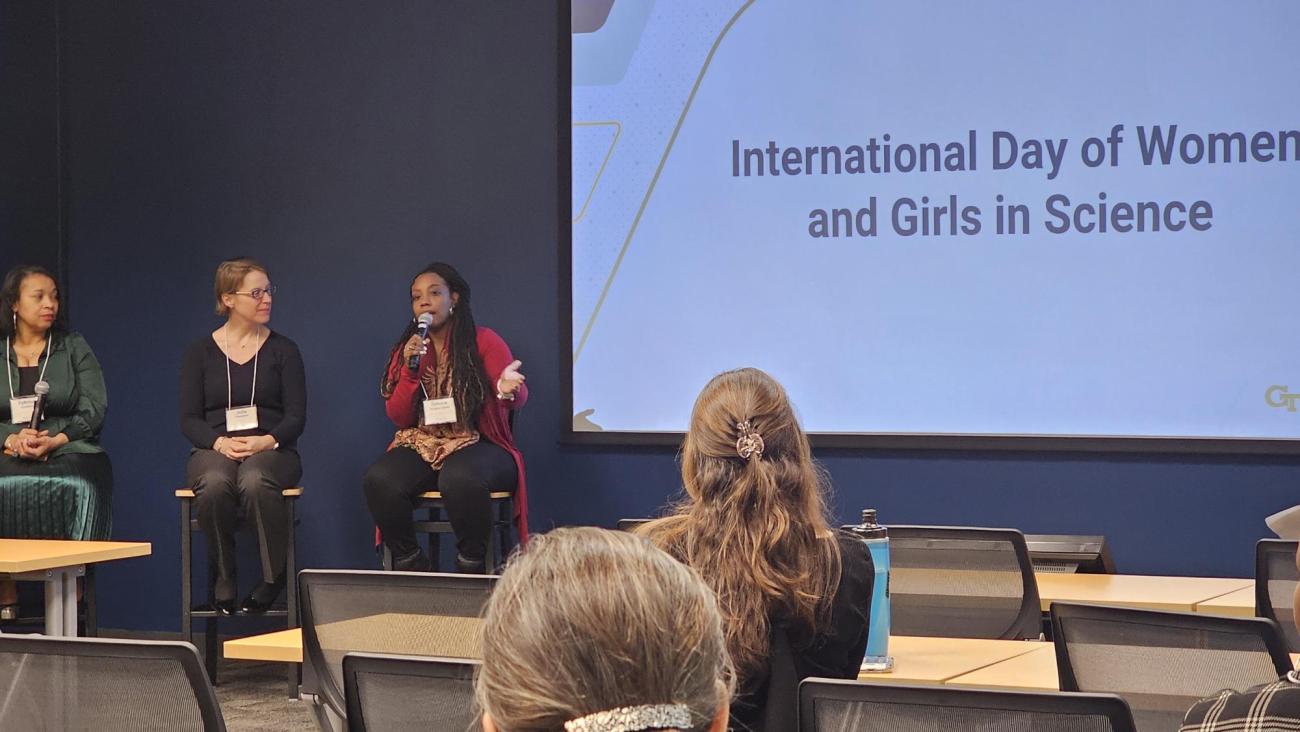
left=365, top=439, right=519, bottom=562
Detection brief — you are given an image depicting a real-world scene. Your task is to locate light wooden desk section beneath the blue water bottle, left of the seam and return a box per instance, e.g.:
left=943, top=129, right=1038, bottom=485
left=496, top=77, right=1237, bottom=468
left=858, top=636, right=1052, bottom=684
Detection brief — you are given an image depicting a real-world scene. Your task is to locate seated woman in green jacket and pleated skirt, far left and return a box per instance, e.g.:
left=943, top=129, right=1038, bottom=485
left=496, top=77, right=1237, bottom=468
left=0, top=267, right=113, bottom=619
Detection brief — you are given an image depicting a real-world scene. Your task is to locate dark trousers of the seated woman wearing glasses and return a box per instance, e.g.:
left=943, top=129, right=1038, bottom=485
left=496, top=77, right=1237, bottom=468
left=185, top=450, right=303, bottom=599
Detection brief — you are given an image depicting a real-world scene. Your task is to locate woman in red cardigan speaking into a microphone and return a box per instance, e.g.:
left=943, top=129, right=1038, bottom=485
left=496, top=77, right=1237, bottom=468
left=365, top=261, right=528, bottom=572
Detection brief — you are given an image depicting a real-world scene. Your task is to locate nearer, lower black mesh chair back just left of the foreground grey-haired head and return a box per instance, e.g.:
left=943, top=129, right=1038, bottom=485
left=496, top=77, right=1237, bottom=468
left=343, top=653, right=482, bottom=732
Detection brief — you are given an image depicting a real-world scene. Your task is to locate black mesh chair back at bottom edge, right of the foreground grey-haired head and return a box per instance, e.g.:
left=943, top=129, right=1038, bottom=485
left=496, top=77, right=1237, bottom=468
left=800, top=679, right=1134, bottom=732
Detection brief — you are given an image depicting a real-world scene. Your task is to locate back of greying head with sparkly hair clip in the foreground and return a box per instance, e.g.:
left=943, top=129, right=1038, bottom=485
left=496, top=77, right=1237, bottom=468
left=476, top=528, right=733, bottom=732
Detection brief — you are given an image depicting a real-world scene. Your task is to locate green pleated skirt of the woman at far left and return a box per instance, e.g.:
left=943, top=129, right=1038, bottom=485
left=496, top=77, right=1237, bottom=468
left=0, top=452, right=113, bottom=541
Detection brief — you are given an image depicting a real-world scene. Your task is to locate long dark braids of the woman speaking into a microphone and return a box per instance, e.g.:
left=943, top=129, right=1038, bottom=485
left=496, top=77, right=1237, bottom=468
left=380, top=261, right=488, bottom=429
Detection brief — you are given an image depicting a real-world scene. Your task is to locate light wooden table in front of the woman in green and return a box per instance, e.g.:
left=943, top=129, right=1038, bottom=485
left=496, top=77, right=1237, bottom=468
left=0, top=538, right=153, bottom=637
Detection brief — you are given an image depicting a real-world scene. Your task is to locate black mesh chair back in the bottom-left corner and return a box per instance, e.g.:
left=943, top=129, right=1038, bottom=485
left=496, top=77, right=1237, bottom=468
left=0, top=636, right=226, bottom=732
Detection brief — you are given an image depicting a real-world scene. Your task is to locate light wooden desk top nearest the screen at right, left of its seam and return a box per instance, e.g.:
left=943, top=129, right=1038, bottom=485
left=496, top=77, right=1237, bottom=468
left=1036, top=573, right=1255, bottom=612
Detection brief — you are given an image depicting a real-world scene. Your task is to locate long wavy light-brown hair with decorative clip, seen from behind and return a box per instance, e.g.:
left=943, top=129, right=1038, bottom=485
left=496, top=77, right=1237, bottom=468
left=638, top=368, right=840, bottom=685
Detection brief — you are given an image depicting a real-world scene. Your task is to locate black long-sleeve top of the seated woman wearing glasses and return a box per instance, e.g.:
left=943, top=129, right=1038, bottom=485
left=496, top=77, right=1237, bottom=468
left=181, top=330, right=307, bottom=450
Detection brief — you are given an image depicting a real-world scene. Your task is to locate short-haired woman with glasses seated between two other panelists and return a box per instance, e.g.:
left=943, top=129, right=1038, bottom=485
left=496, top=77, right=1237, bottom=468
left=181, top=257, right=307, bottom=615
